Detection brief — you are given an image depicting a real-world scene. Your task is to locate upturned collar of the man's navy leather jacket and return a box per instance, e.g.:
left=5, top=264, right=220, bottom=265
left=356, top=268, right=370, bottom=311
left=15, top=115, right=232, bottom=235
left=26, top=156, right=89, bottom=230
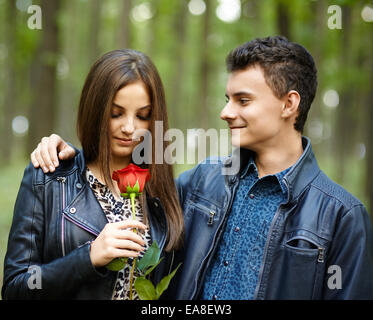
left=223, top=136, right=320, bottom=203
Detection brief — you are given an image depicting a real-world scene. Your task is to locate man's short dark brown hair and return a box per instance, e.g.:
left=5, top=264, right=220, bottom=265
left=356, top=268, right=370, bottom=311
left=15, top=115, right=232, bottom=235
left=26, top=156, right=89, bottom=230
left=226, top=36, right=317, bottom=132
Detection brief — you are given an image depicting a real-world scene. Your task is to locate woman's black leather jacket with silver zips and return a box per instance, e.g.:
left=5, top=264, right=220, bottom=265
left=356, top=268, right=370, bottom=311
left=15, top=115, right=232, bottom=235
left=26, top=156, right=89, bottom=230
left=1, top=152, right=168, bottom=299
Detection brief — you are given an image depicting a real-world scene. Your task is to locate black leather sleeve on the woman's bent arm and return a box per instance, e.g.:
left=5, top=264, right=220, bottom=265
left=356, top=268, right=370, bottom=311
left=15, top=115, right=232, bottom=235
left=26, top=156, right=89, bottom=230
left=2, top=164, right=107, bottom=299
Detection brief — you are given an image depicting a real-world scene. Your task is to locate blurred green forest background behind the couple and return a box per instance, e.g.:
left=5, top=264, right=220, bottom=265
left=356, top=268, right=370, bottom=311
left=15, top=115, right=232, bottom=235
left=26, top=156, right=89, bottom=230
left=0, top=0, right=373, bottom=292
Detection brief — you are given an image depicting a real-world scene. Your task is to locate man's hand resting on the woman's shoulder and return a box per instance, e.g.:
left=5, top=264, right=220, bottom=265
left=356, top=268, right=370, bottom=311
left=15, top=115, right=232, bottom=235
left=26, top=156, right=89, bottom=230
left=31, top=134, right=75, bottom=173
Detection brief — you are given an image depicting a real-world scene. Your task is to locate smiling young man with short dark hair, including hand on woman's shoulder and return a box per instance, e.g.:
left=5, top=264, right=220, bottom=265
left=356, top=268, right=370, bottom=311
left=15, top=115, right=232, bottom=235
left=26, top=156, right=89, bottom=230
left=32, top=37, right=373, bottom=299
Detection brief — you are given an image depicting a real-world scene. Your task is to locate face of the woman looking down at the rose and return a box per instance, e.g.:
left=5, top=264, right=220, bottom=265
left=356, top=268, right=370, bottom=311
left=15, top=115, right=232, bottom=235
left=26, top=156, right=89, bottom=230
left=110, top=81, right=151, bottom=167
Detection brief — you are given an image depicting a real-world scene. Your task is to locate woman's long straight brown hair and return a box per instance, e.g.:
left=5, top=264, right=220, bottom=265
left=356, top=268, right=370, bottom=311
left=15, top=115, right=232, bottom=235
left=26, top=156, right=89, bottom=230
left=77, top=49, right=184, bottom=251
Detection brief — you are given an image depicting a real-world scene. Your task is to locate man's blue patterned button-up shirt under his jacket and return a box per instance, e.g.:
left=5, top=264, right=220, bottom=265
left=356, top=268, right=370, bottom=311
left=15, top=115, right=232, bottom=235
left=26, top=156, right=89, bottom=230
left=202, top=159, right=291, bottom=300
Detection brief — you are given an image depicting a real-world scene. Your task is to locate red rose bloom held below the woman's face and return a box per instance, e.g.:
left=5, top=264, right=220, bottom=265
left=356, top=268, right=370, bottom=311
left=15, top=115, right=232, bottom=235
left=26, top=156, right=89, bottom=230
left=112, top=163, right=150, bottom=196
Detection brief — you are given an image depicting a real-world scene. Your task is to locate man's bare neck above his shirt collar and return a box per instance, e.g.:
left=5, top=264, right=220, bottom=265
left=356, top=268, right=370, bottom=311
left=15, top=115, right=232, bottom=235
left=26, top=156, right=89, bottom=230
left=255, top=134, right=303, bottom=178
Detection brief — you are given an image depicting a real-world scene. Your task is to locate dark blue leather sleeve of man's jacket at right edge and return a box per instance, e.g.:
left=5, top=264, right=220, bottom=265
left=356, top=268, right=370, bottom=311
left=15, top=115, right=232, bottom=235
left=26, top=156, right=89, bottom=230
left=324, top=205, right=373, bottom=300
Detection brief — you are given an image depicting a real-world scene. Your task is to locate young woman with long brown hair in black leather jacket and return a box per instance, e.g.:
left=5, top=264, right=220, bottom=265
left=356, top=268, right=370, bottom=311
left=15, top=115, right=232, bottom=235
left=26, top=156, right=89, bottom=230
left=2, top=50, right=183, bottom=299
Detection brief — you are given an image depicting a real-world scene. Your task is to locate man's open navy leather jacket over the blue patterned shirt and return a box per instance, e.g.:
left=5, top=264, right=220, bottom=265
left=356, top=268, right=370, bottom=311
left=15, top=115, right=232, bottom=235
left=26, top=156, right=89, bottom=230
left=168, top=137, right=373, bottom=300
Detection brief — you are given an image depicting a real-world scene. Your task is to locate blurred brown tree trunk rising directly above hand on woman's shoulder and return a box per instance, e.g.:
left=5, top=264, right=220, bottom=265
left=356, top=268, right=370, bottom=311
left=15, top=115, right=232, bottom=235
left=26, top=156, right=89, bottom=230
left=27, top=0, right=60, bottom=153
